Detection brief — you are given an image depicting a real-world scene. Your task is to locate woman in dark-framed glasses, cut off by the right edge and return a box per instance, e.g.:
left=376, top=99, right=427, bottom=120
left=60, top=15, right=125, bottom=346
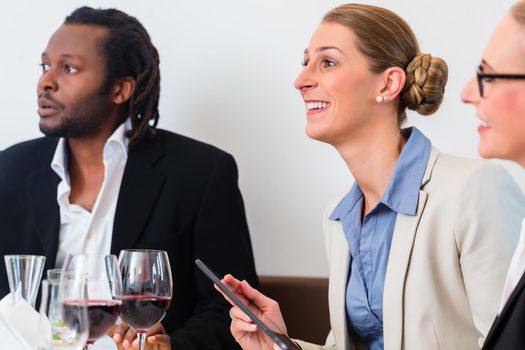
left=461, top=1, right=525, bottom=349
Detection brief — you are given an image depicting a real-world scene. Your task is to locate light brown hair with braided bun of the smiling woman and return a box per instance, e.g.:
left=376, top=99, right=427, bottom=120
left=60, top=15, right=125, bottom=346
left=323, top=4, right=448, bottom=124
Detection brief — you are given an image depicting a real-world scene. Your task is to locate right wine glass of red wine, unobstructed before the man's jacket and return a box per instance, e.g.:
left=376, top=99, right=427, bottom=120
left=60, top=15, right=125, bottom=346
left=117, top=249, right=173, bottom=350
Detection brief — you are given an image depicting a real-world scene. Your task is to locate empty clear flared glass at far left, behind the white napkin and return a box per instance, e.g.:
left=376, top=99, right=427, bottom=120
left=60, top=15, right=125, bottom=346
left=4, top=255, right=46, bottom=307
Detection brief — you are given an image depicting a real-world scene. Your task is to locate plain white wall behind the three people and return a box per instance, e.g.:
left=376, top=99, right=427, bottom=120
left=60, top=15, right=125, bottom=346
left=0, top=0, right=525, bottom=276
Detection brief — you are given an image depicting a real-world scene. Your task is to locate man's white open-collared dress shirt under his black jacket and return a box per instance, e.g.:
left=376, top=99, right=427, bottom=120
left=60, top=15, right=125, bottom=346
left=51, top=119, right=131, bottom=280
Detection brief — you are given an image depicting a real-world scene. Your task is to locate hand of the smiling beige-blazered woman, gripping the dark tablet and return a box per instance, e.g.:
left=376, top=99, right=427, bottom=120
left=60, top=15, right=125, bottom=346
left=219, top=275, right=288, bottom=350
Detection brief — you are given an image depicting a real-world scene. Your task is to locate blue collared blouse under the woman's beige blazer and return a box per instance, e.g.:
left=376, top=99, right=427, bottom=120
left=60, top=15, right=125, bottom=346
left=330, top=128, right=432, bottom=350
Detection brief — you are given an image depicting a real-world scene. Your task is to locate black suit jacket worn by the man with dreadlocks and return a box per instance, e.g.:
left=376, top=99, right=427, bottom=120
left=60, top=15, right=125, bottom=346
left=0, top=130, right=257, bottom=350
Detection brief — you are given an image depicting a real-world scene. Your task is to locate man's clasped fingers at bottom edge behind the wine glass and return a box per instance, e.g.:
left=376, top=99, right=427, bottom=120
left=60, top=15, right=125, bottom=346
left=108, top=323, right=171, bottom=350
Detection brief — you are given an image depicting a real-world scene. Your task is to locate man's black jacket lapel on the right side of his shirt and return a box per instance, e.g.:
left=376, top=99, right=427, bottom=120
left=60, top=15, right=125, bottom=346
left=111, top=137, right=164, bottom=254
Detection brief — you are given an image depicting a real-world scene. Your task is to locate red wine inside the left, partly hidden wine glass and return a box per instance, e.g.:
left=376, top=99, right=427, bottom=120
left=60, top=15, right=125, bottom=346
left=64, top=300, right=122, bottom=344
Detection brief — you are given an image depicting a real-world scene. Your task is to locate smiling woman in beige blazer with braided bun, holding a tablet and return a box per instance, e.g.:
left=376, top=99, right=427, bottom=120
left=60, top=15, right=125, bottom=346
left=219, top=4, right=525, bottom=350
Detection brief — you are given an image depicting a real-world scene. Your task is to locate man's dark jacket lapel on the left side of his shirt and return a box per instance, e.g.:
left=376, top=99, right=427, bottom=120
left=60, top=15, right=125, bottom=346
left=26, top=140, right=60, bottom=267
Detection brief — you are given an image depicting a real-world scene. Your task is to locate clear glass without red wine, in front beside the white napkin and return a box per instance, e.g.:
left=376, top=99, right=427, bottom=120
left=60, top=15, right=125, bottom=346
left=39, top=274, right=89, bottom=350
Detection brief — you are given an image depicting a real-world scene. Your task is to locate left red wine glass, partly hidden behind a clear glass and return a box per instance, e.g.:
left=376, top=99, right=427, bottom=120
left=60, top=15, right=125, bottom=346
left=64, top=255, right=122, bottom=350
